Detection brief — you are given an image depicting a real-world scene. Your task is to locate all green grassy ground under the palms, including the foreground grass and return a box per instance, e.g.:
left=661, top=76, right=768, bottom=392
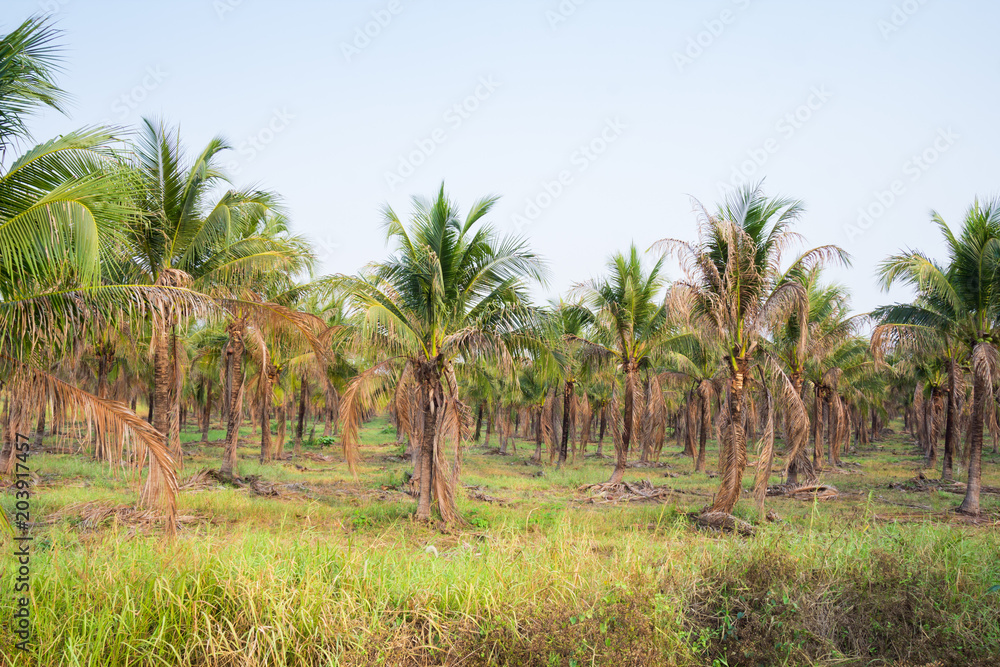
left=0, top=419, right=1000, bottom=667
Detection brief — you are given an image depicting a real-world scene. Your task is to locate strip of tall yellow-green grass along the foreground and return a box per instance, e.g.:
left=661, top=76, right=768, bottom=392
left=0, top=508, right=1000, bottom=667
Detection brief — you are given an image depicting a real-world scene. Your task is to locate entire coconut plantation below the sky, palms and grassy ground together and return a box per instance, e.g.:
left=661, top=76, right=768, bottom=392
left=0, top=11, right=1000, bottom=667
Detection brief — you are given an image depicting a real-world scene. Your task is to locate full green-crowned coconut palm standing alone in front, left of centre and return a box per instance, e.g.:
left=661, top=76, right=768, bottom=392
left=342, top=184, right=545, bottom=522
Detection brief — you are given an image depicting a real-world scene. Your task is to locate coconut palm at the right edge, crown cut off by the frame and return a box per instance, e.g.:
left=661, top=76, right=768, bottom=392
left=872, top=198, right=1000, bottom=515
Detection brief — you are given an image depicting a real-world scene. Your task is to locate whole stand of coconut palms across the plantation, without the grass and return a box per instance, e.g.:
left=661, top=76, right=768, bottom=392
left=0, top=14, right=1000, bottom=526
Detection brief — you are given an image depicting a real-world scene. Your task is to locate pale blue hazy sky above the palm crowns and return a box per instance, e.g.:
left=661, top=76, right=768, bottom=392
left=0, top=0, right=1000, bottom=310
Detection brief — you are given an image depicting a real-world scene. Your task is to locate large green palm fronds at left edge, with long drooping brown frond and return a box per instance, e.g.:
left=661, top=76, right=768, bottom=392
left=0, top=18, right=178, bottom=526
